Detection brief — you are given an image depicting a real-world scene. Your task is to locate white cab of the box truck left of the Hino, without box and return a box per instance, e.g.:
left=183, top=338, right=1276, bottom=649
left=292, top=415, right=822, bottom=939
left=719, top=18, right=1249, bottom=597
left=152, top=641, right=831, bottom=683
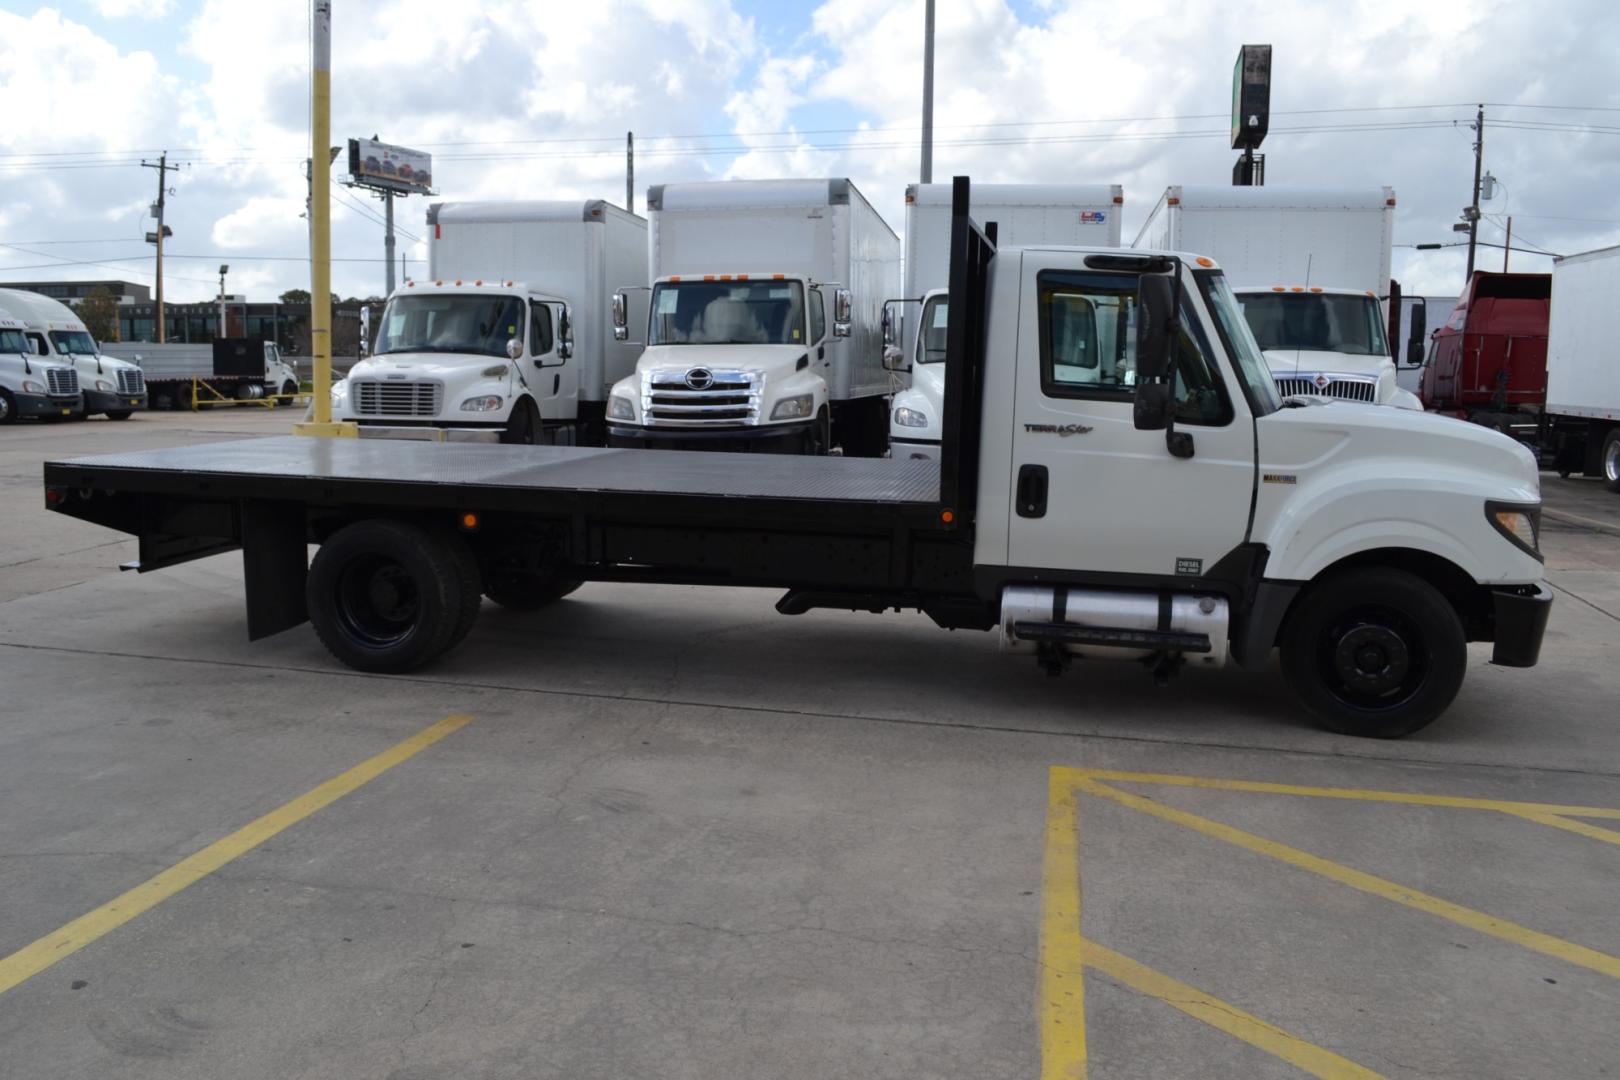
left=332, top=280, right=580, bottom=444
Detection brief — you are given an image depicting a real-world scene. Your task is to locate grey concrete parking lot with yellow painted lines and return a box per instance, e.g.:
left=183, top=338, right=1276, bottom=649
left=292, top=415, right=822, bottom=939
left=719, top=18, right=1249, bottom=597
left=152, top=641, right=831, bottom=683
left=0, top=408, right=1620, bottom=1080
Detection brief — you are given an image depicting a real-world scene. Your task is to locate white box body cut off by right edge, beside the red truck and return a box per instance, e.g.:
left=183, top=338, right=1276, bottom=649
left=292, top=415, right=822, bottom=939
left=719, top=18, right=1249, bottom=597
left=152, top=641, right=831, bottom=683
left=1542, top=248, right=1620, bottom=492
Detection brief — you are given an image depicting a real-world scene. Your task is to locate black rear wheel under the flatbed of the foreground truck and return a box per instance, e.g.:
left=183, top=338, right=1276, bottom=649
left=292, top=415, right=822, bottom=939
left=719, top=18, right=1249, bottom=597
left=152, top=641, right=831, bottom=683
left=305, top=518, right=478, bottom=674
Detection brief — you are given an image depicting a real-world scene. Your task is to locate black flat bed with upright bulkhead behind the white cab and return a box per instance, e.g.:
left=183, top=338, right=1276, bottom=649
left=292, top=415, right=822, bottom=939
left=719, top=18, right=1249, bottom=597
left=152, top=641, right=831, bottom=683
left=44, top=178, right=996, bottom=638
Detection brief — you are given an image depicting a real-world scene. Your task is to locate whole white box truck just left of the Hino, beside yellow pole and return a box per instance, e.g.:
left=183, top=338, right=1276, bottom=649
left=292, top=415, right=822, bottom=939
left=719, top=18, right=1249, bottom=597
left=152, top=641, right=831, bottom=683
left=332, top=199, right=646, bottom=445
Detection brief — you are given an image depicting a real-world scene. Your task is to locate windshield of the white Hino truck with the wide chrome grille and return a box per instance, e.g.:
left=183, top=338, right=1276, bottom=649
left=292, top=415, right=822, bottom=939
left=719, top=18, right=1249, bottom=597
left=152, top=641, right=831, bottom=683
left=646, top=280, right=807, bottom=345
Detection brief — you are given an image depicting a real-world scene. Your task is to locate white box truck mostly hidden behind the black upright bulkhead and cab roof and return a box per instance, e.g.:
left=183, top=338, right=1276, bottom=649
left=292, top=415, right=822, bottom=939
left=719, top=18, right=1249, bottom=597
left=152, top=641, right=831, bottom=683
left=886, top=183, right=1124, bottom=461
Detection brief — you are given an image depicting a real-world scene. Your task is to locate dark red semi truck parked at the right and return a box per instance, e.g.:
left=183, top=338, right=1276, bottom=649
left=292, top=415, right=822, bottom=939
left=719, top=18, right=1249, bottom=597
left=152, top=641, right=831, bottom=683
left=1419, top=270, right=1552, bottom=442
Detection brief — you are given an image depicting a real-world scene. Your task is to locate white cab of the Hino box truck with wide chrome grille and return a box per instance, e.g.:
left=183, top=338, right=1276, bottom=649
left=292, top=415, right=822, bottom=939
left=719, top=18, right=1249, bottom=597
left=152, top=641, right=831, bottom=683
left=608, top=272, right=849, bottom=453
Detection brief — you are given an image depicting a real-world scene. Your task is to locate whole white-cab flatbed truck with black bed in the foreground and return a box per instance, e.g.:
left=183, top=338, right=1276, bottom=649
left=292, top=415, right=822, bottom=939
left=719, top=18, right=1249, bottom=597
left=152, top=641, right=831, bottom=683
left=44, top=178, right=1552, bottom=737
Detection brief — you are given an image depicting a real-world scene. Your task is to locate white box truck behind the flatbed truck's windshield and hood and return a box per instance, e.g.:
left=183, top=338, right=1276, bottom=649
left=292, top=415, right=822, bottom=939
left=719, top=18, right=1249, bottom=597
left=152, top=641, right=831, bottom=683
left=1132, top=185, right=1422, bottom=408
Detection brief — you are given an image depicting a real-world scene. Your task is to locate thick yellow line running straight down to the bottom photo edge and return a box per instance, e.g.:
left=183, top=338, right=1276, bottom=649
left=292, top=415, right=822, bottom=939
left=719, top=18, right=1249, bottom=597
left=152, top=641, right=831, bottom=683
left=1037, top=769, right=1085, bottom=1080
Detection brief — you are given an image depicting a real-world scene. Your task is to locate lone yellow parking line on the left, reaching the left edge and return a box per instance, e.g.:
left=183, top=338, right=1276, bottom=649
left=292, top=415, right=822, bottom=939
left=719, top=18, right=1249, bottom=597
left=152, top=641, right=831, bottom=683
left=0, top=716, right=473, bottom=994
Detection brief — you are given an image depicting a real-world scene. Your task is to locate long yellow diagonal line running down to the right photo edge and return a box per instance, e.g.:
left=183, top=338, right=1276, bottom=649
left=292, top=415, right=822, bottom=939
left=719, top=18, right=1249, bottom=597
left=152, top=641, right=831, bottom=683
left=1074, top=776, right=1620, bottom=978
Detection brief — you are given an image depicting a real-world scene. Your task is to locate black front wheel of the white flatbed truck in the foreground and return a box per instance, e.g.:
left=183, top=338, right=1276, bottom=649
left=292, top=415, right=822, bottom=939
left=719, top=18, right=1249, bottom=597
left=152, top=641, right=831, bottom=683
left=1281, top=567, right=1468, bottom=738
